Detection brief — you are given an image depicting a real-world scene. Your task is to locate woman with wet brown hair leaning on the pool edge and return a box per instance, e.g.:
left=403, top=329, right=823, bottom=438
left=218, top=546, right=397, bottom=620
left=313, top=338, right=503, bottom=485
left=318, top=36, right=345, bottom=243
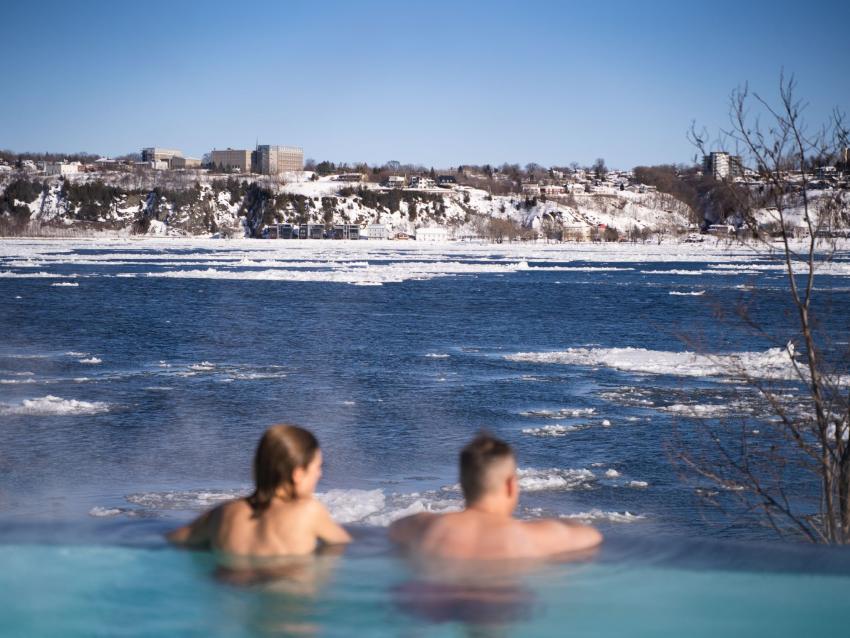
left=168, top=425, right=351, bottom=557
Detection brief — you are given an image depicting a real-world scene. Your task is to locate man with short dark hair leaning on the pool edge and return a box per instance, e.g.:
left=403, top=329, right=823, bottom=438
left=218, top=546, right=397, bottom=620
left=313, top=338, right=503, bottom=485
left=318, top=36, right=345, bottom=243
left=389, top=434, right=602, bottom=560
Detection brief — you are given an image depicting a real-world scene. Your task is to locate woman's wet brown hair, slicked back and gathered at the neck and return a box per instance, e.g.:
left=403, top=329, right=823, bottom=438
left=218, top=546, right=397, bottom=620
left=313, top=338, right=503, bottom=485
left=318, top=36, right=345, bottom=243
left=248, top=424, right=319, bottom=514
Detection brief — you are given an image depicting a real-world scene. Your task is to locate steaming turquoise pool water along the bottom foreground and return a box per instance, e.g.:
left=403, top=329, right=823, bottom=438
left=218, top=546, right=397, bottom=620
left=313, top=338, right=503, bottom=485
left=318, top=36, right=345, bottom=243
left=0, top=527, right=850, bottom=636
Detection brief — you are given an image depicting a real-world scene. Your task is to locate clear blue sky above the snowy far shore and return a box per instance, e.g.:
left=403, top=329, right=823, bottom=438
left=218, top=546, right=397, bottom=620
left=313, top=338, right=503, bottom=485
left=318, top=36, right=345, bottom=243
left=0, top=0, right=850, bottom=168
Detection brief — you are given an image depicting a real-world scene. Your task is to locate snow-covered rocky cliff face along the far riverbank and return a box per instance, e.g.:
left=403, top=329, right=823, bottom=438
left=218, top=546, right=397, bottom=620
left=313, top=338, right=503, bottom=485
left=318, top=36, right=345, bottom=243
left=0, top=173, right=692, bottom=237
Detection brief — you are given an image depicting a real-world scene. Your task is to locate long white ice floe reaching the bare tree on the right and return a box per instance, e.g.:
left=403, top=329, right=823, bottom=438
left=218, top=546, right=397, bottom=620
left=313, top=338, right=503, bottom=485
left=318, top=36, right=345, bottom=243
left=505, top=345, right=800, bottom=380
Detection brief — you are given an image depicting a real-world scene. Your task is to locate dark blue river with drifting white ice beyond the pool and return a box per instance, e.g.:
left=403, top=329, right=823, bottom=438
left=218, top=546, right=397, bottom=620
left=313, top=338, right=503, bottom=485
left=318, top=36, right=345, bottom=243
left=0, top=239, right=850, bottom=633
